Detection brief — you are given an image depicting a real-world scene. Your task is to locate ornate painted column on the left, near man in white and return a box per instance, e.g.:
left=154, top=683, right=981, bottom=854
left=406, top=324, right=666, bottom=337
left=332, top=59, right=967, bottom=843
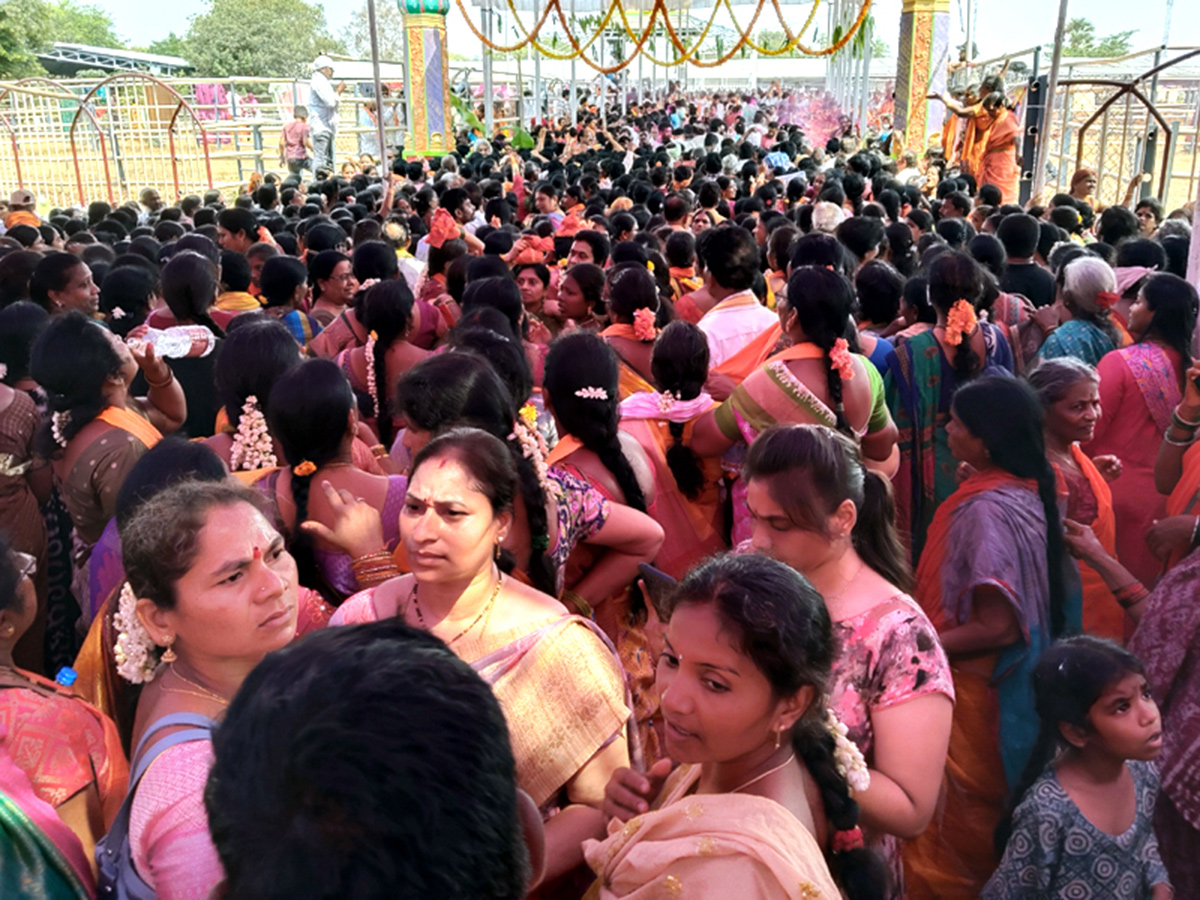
left=397, top=0, right=454, bottom=156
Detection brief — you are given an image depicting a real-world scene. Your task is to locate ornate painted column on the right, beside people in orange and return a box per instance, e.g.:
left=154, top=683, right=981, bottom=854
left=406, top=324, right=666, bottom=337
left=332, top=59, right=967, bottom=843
left=894, top=0, right=950, bottom=154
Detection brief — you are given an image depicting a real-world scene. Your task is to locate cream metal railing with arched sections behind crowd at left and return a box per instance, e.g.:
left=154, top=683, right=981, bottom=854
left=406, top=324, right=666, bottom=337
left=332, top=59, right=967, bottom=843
left=0, top=72, right=424, bottom=206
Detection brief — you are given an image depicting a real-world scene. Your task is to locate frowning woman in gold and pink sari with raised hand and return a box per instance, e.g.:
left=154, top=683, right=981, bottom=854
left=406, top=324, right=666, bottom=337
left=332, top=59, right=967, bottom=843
left=330, top=428, right=630, bottom=897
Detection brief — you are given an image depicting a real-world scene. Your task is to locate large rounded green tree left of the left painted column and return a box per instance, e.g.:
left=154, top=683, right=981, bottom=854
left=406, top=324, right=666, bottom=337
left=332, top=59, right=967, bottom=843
left=184, top=0, right=342, bottom=78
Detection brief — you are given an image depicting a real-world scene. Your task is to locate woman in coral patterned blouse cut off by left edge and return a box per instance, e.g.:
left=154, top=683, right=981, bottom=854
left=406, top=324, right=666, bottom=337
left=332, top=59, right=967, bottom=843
left=0, top=535, right=128, bottom=896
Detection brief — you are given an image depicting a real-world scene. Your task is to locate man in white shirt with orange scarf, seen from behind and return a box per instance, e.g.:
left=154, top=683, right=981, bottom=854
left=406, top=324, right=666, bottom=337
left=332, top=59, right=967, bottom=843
left=700, top=226, right=776, bottom=368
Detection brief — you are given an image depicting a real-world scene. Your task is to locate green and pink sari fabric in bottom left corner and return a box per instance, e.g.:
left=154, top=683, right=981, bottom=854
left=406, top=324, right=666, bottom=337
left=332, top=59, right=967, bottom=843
left=0, top=730, right=96, bottom=900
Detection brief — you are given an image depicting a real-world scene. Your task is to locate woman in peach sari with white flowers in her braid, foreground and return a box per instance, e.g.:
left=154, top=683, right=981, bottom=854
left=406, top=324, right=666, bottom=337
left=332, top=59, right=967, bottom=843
left=584, top=554, right=886, bottom=900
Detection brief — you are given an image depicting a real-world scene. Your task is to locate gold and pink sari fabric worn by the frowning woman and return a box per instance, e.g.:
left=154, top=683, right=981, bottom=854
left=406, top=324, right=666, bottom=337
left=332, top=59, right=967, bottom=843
left=330, top=600, right=630, bottom=808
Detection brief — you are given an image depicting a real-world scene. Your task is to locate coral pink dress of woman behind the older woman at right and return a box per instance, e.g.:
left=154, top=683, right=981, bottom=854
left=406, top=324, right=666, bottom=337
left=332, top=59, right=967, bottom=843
left=1084, top=342, right=1182, bottom=587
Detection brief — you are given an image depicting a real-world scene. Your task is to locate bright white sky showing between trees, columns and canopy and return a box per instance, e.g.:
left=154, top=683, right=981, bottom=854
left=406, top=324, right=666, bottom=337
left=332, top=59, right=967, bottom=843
left=110, top=0, right=1200, bottom=66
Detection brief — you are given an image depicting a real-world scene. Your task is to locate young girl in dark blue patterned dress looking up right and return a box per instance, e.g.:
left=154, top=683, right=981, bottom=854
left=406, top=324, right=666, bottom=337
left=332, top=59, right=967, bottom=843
left=983, top=636, right=1174, bottom=900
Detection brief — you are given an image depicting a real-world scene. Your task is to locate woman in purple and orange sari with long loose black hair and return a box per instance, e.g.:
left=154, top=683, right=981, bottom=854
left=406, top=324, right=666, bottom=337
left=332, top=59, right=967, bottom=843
left=904, top=377, right=1080, bottom=900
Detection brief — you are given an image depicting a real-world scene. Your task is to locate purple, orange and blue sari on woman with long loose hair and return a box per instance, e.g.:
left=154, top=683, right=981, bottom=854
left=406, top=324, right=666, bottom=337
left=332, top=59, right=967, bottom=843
left=904, top=469, right=1079, bottom=900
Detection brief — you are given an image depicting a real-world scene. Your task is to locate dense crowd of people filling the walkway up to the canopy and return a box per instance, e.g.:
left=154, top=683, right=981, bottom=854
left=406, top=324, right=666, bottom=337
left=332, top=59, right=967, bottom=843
left=0, top=72, right=1200, bottom=900
